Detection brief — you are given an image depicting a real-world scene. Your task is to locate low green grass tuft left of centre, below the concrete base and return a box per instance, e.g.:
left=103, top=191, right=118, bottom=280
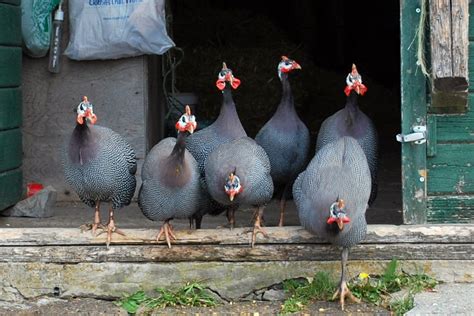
left=116, top=282, right=217, bottom=314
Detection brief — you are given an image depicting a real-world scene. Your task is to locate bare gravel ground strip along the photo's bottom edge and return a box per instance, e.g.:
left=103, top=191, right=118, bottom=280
left=0, top=298, right=390, bottom=316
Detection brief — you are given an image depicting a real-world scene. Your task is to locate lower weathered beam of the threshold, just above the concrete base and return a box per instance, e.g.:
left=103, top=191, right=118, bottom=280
left=0, top=243, right=474, bottom=264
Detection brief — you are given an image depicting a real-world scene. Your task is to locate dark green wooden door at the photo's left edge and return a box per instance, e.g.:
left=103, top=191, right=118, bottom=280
left=0, top=0, right=23, bottom=210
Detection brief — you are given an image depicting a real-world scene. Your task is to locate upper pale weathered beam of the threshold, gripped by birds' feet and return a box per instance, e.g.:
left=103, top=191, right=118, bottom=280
left=0, top=225, right=474, bottom=247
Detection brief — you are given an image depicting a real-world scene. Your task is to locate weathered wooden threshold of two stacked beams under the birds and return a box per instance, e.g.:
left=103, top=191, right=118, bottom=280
left=0, top=225, right=474, bottom=263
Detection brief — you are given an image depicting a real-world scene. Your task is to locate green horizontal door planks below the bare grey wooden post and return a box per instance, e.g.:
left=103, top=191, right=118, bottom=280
left=427, top=4, right=474, bottom=223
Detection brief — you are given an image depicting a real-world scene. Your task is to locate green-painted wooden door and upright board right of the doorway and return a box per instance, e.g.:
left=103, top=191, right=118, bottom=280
left=400, top=0, right=474, bottom=224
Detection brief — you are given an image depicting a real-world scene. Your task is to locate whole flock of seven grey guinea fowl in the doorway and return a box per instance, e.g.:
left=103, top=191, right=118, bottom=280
left=64, top=56, right=378, bottom=308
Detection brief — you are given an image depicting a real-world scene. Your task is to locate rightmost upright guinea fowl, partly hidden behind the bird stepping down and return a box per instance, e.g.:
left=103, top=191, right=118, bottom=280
left=316, top=64, right=378, bottom=205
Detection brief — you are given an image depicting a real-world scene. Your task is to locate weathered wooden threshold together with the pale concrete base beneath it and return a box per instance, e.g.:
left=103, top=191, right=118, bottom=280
left=0, top=225, right=474, bottom=301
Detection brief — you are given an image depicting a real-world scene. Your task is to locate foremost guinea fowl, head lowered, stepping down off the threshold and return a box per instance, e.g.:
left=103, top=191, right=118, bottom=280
left=293, top=137, right=371, bottom=309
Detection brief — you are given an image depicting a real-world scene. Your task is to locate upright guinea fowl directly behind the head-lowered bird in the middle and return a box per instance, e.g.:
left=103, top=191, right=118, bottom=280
left=186, top=63, right=247, bottom=228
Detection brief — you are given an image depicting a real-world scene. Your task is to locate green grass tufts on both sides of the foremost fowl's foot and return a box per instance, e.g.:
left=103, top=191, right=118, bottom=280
left=281, top=260, right=438, bottom=315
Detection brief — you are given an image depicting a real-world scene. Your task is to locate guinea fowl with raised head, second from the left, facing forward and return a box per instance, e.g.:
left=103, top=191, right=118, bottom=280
left=138, top=106, right=201, bottom=248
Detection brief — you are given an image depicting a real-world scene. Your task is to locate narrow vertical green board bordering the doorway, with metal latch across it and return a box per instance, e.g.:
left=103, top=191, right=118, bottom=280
left=400, top=0, right=427, bottom=224
